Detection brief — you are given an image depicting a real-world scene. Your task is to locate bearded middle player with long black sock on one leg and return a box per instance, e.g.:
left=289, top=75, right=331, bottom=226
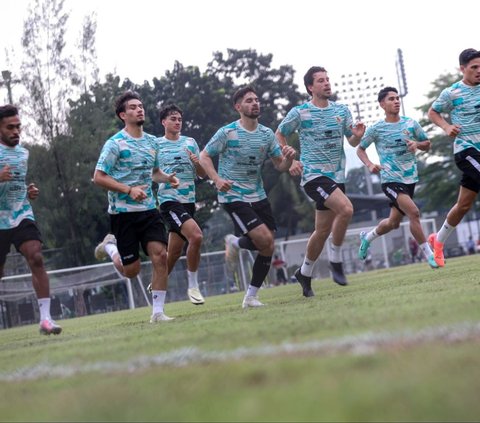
left=200, top=86, right=295, bottom=308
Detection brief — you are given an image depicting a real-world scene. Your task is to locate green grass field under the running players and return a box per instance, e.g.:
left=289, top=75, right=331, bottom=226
left=0, top=255, right=480, bottom=421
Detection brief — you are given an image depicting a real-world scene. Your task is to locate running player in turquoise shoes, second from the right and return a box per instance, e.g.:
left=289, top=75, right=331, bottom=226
left=357, top=87, right=438, bottom=268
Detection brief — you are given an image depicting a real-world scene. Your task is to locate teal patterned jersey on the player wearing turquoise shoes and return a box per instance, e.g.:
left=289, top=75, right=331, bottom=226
left=360, top=116, right=428, bottom=184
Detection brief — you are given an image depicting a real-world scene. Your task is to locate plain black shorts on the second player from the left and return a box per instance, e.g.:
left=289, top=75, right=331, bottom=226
left=110, top=209, right=167, bottom=265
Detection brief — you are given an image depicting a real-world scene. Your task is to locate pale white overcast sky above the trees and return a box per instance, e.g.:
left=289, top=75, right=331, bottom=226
left=0, top=0, right=480, bottom=169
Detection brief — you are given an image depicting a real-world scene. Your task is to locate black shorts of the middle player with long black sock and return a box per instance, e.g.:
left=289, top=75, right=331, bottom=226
left=223, top=198, right=277, bottom=236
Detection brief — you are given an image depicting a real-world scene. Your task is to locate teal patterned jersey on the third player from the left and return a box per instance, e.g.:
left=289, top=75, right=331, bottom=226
left=157, top=135, right=200, bottom=204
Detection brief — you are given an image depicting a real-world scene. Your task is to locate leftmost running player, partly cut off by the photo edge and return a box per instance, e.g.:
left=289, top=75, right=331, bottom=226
left=0, top=104, right=62, bottom=335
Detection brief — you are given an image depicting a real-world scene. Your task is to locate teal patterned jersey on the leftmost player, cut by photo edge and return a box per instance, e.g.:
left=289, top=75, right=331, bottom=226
left=0, top=144, right=35, bottom=230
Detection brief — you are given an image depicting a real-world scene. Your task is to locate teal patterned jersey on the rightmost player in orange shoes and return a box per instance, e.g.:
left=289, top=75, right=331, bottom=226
left=432, top=81, right=480, bottom=154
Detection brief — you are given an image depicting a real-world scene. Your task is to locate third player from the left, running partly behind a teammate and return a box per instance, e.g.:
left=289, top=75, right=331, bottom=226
left=148, top=104, right=207, bottom=305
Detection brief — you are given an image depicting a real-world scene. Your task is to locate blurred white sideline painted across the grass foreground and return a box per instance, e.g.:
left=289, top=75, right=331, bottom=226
left=0, top=322, right=480, bottom=382
